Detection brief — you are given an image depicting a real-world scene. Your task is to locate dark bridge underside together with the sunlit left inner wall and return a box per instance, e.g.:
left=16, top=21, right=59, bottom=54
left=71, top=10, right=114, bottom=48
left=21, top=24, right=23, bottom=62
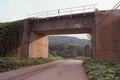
left=28, top=28, right=91, bottom=58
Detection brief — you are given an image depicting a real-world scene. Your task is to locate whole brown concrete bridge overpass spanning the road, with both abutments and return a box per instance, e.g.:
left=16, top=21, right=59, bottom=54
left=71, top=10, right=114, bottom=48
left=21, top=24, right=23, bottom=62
left=20, top=5, right=120, bottom=60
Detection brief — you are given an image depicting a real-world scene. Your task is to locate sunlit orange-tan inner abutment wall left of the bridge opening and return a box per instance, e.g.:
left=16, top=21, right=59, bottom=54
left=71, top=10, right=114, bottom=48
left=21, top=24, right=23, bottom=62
left=28, top=32, right=48, bottom=58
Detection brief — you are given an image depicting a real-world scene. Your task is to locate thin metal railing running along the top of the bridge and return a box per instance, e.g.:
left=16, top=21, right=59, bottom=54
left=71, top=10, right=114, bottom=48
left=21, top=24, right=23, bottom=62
left=27, top=4, right=96, bottom=18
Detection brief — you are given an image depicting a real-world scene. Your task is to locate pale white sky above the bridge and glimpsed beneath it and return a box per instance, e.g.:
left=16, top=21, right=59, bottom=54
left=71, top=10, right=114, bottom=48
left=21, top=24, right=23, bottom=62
left=0, top=0, right=119, bottom=38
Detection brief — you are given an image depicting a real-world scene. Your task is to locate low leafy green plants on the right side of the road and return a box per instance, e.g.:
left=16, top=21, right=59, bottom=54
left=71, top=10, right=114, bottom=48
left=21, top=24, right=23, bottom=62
left=78, top=57, right=120, bottom=80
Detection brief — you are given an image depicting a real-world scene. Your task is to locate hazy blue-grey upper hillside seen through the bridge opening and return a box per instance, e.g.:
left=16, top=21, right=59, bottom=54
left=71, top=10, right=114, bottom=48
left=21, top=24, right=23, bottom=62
left=49, top=36, right=90, bottom=47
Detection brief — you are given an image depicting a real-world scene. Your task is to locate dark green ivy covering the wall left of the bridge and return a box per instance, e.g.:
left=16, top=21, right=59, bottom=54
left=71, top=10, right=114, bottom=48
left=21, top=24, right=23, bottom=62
left=0, top=21, right=23, bottom=57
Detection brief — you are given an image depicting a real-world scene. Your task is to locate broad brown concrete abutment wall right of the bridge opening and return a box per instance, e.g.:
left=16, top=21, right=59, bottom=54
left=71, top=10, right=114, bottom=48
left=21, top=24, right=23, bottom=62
left=96, top=12, right=120, bottom=61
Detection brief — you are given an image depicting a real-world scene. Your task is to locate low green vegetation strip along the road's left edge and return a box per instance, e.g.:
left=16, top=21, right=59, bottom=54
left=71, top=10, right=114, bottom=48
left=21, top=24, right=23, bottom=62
left=0, top=56, right=62, bottom=72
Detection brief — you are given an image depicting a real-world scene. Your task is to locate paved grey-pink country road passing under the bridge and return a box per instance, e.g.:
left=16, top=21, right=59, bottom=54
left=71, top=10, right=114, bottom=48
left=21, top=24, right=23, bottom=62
left=0, top=60, right=88, bottom=80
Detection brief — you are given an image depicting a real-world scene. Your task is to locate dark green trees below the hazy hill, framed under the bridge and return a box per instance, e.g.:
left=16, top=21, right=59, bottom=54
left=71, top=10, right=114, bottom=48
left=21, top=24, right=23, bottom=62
left=49, top=42, right=90, bottom=58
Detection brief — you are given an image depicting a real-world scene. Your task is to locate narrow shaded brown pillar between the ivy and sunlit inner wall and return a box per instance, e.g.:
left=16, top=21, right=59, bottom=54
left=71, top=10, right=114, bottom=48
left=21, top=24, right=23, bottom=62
left=18, top=20, right=31, bottom=58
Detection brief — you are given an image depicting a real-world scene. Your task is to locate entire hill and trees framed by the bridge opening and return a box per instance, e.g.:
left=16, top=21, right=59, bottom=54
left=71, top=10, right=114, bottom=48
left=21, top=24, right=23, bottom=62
left=49, top=36, right=90, bottom=57
